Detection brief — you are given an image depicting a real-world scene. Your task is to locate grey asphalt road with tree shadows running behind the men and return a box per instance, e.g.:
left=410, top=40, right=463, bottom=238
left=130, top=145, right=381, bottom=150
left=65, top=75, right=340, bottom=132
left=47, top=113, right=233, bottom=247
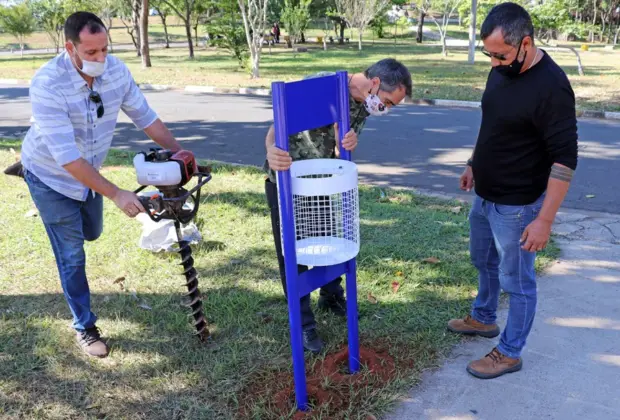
left=0, top=86, right=620, bottom=213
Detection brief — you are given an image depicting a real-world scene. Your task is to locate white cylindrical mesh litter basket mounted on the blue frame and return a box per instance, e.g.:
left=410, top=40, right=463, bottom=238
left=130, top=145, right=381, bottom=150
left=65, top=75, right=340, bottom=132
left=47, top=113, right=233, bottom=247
left=284, top=159, right=360, bottom=266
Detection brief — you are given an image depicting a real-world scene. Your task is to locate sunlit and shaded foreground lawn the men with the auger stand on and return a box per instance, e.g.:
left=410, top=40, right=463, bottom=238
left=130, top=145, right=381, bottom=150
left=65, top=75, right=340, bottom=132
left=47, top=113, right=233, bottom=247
left=0, top=140, right=557, bottom=419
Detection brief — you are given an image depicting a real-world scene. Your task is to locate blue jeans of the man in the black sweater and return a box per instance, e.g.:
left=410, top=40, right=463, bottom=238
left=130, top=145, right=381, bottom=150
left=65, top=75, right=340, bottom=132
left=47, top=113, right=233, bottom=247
left=469, top=195, right=544, bottom=358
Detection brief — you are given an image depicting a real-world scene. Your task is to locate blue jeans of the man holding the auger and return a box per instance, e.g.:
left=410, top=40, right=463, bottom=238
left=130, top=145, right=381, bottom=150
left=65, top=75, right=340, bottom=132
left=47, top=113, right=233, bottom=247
left=24, top=171, right=103, bottom=330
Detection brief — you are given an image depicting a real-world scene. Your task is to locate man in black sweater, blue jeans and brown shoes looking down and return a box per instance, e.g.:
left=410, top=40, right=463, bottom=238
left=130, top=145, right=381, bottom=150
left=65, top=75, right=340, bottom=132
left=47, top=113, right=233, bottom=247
left=448, top=3, right=577, bottom=379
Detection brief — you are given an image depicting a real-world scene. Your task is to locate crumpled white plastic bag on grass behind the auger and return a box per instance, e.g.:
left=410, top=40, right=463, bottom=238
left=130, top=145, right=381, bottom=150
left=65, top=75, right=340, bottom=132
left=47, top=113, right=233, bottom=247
left=136, top=213, right=202, bottom=252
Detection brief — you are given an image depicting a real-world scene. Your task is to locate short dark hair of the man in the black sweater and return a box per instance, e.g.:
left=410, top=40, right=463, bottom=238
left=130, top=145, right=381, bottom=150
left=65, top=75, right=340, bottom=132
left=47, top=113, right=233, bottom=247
left=480, top=3, right=534, bottom=47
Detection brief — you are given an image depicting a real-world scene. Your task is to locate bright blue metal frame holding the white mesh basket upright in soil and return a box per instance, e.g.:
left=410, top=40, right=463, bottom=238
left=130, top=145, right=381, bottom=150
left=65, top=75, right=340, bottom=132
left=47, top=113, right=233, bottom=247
left=271, top=71, right=360, bottom=411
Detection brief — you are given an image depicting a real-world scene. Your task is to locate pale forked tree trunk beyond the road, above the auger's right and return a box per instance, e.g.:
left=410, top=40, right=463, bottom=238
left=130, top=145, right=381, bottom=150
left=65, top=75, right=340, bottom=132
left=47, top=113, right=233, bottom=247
left=237, top=0, right=269, bottom=79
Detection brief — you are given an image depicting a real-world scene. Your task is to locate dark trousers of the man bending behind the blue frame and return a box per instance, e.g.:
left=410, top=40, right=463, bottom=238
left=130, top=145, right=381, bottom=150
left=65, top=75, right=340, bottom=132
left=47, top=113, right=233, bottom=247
left=265, top=179, right=344, bottom=330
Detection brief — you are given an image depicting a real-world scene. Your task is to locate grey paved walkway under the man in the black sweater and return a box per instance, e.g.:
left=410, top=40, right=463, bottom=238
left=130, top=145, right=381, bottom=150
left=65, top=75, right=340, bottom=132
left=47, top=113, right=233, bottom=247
left=385, top=212, right=620, bottom=420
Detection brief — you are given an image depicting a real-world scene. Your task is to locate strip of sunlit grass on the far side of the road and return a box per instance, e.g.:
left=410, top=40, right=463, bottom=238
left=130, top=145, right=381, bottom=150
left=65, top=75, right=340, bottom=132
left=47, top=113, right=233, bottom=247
left=0, top=37, right=620, bottom=111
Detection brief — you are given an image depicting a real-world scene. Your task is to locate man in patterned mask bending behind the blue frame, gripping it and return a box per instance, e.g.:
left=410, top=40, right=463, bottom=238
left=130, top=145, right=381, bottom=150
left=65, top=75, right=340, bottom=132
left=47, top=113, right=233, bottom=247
left=264, top=59, right=411, bottom=353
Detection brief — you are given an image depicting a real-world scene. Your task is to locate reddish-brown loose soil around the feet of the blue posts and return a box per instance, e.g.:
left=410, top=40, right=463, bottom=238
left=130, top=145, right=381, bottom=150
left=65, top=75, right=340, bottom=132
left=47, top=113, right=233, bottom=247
left=240, top=347, right=397, bottom=420
